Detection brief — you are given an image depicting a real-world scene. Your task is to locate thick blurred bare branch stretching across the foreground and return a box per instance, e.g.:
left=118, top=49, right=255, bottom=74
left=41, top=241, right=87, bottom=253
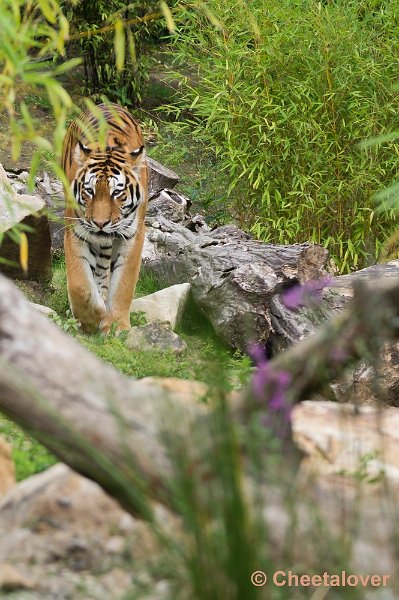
left=0, top=276, right=399, bottom=518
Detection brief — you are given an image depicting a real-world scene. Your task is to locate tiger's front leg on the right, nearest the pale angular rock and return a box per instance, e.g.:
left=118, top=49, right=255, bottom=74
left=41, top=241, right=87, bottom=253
left=100, top=227, right=144, bottom=333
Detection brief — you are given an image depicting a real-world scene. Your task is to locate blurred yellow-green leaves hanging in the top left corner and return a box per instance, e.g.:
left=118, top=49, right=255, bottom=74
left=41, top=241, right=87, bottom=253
left=0, top=0, right=76, bottom=183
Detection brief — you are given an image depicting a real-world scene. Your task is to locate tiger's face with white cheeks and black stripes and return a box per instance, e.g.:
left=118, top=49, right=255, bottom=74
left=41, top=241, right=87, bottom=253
left=71, top=142, right=145, bottom=239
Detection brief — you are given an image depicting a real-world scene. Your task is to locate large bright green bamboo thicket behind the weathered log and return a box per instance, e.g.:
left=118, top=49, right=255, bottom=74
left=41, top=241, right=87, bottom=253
left=169, top=0, right=399, bottom=271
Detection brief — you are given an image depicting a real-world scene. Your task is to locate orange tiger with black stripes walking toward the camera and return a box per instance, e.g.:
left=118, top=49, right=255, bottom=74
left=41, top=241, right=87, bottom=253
left=61, top=104, right=148, bottom=334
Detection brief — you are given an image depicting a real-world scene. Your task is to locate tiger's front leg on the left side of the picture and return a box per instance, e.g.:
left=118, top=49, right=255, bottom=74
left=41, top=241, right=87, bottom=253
left=64, top=229, right=107, bottom=333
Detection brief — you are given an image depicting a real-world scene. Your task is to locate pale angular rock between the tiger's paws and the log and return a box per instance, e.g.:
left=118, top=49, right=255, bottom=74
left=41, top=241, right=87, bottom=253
left=130, top=283, right=190, bottom=331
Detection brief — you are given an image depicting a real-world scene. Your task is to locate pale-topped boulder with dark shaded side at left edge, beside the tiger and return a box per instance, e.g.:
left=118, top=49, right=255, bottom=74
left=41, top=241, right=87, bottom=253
left=0, top=165, right=51, bottom=281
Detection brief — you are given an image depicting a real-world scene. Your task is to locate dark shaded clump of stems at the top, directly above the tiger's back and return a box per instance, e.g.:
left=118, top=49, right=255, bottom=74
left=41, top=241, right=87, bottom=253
left=62, top=0, right=173, bottom=106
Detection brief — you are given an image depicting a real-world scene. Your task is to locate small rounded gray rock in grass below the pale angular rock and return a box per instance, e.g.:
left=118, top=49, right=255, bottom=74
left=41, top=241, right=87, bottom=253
left=125, top=321, right=187, bottom=355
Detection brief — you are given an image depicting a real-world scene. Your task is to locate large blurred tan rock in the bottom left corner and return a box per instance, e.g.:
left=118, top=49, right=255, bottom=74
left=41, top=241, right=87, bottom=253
left=0, top=464, right=168, bottom=600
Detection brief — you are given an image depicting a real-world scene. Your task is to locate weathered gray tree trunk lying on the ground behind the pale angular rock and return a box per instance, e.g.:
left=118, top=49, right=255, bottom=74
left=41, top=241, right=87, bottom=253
left=143, top=214, right=328, bottom=351
